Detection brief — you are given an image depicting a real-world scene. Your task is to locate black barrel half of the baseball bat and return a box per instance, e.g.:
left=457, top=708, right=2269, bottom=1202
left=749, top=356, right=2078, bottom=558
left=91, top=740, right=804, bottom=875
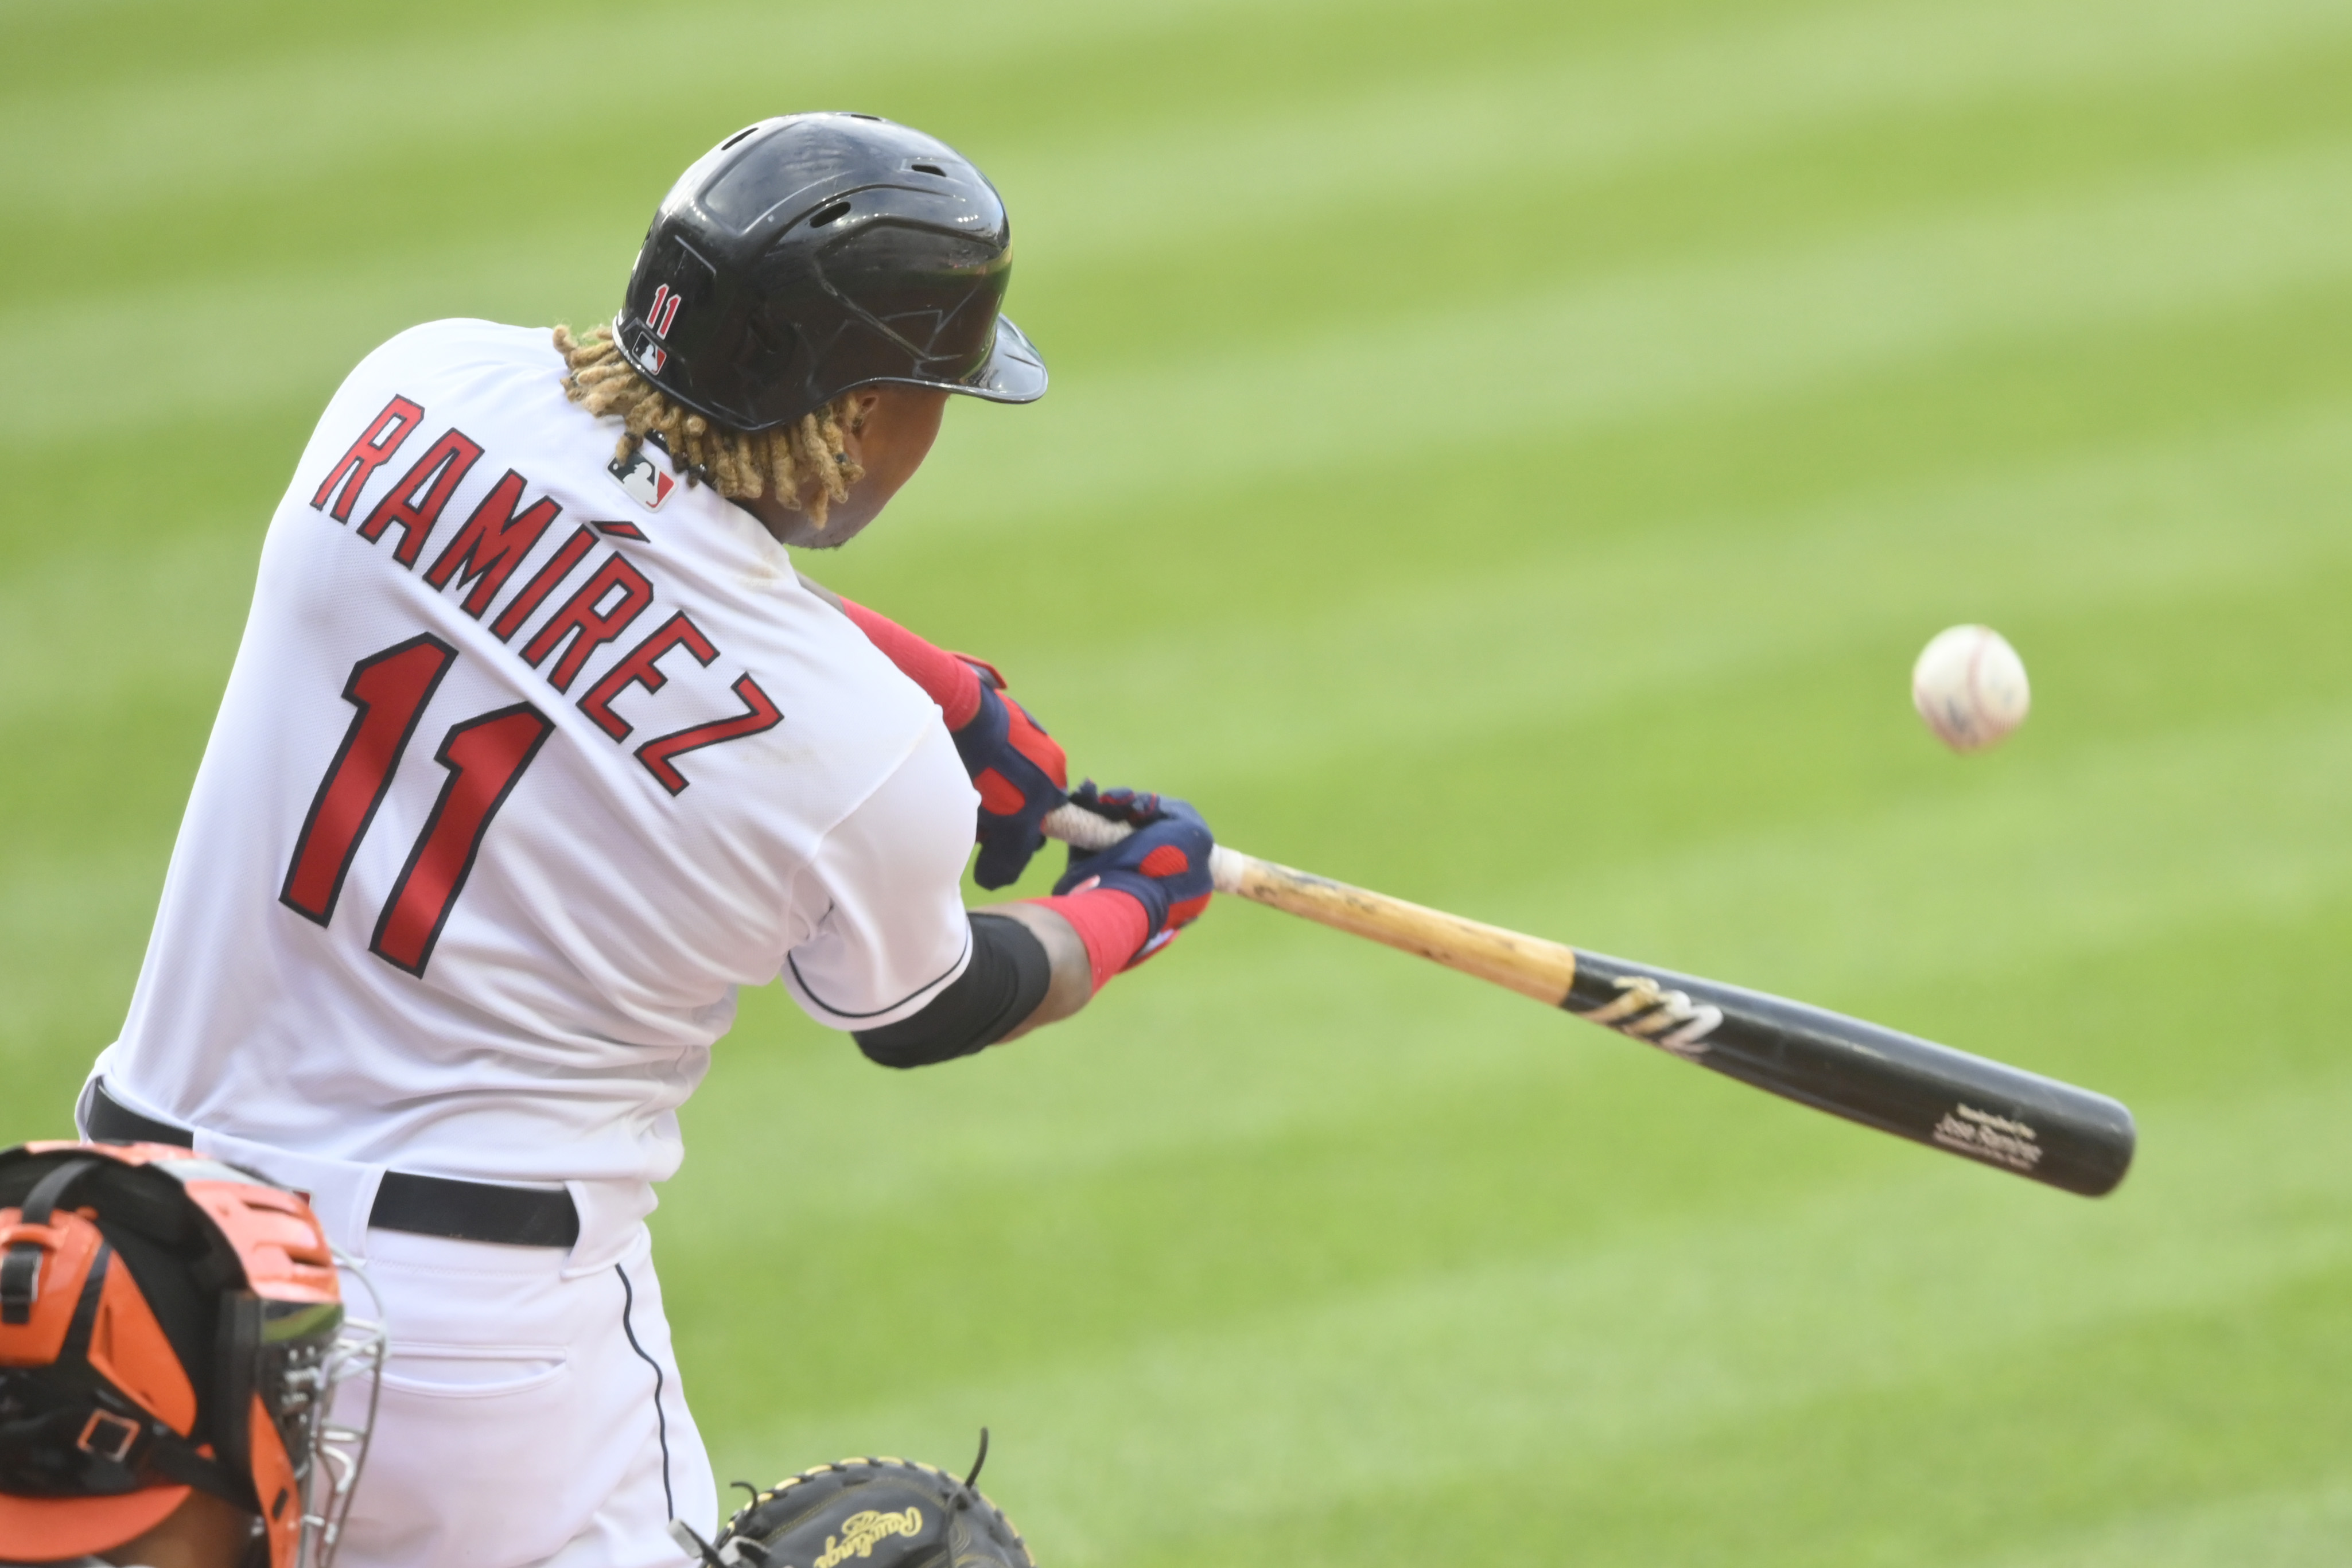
left=1560, top=950, right=2136, bottom=1197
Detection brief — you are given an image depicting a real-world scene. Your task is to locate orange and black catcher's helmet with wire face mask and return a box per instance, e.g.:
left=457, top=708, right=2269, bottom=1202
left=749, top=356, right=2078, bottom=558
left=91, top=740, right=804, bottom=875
left=0, top=1142, right=383, bottom=1568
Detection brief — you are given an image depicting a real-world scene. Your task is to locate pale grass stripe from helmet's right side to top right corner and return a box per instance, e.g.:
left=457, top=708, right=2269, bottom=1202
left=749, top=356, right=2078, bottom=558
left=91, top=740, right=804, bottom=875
left=1004, top=0, right=2352, bottom=270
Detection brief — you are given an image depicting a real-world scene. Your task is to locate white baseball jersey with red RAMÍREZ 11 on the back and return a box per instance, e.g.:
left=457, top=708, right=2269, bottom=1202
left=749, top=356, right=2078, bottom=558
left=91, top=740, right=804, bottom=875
left=99, top=320, right=978, bottom=1182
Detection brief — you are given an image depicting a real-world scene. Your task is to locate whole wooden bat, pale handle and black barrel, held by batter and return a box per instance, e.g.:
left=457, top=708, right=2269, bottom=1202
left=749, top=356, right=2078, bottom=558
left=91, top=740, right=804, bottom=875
left=1044, top=806, right=2136, bottom=1197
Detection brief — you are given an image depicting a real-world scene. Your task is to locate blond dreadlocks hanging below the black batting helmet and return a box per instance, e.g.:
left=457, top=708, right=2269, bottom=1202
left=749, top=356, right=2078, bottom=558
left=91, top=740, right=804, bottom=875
left=555, top=324, right=865, bottom=529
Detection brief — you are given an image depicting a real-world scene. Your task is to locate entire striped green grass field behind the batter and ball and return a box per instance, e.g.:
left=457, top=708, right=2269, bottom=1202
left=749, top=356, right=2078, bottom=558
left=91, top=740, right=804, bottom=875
left=0, top=0, right=2352, bottom=1568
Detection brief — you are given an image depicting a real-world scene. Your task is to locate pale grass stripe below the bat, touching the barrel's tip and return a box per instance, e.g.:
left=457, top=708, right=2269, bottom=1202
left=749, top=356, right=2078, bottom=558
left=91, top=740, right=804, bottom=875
left=720, top=1079, right=2352, bottom=1561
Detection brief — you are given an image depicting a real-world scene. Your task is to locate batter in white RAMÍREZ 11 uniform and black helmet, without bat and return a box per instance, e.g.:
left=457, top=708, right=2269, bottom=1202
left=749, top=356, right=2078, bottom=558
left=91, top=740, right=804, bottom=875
left=55, top=113, right=1211, bottom=1568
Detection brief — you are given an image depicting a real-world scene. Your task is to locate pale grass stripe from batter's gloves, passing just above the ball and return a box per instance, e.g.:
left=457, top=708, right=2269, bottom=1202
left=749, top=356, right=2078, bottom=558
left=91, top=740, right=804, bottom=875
left=1039, top=402, right=2352, bottom=788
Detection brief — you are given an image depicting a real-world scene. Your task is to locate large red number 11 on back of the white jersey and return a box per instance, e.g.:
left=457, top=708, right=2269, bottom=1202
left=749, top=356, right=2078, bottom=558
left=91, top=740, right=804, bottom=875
left=278, top=632, right=555, bottom=978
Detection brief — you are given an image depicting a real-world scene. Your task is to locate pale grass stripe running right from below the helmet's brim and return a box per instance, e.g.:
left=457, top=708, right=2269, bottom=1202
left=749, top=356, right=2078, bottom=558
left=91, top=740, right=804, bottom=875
left=910, top=143, right=2352, bottom=527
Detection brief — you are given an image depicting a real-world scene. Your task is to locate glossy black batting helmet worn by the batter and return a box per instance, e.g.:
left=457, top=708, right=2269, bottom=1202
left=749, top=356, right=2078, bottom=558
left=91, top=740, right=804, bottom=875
left=614, top=113, right=1044, bottom=430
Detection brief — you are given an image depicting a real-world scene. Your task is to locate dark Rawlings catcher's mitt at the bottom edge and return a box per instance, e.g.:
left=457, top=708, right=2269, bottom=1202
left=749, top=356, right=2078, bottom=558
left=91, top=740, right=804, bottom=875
left=686, top=1446, right=1037, bottom=1568
